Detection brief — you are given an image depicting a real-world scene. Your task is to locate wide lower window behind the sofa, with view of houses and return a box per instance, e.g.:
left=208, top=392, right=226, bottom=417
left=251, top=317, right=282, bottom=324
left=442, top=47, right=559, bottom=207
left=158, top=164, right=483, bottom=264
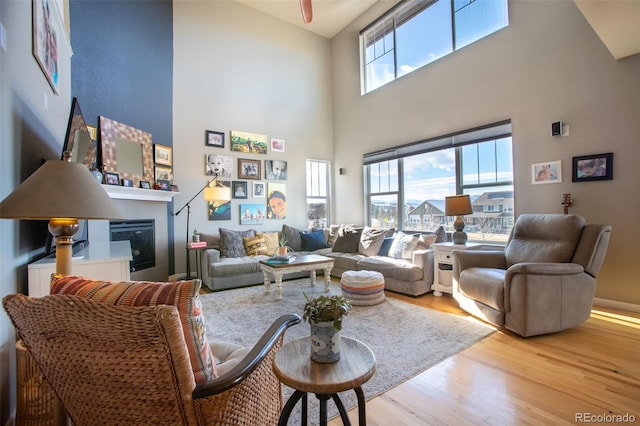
left=364, top=122, right=513, bottom=242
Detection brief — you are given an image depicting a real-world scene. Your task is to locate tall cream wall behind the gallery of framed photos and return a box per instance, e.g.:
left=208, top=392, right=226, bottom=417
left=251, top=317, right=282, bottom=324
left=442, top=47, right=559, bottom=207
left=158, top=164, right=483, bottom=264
left=173, top=1, right=333, bottom=272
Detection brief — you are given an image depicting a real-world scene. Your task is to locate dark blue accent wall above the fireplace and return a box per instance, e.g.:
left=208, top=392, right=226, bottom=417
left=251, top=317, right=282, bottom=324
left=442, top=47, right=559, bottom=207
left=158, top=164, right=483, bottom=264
left=69, top=0, right=175, bottom=274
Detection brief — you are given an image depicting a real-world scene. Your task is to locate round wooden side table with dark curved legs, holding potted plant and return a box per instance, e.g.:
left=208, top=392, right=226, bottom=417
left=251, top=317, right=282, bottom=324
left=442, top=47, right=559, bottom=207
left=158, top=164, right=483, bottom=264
left=273, top=337, right=376, bottom=426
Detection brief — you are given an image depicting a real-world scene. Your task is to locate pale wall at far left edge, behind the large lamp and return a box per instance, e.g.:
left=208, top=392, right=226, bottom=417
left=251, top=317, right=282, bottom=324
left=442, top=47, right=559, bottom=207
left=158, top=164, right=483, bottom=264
left=0, top=1, right=71, bottom=424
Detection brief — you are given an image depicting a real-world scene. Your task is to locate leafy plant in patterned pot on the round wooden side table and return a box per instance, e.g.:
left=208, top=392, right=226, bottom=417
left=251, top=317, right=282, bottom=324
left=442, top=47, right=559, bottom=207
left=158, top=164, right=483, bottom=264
left=302, top=293, right=351, bottom=363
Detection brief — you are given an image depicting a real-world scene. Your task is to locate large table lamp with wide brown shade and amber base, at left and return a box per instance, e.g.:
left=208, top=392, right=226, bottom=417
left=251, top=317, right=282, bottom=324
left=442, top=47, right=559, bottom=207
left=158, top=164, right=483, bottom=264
left=0, top=153, right=125, bottom=275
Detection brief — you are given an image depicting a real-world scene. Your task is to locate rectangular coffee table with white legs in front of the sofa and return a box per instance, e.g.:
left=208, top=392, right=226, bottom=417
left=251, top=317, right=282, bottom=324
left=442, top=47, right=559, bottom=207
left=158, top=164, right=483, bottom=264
left=260, top=254, right=333, bottom=299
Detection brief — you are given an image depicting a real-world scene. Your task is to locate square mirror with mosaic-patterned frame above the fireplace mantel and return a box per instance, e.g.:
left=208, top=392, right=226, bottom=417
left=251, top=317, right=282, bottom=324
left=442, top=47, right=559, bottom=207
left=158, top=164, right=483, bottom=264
left=100, top=116, right=154, bottom=187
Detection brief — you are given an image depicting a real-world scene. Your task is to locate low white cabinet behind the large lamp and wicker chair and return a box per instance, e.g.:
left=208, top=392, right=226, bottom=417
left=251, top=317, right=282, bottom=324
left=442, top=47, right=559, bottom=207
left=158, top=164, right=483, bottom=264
left=28, top=241, right=132, bottom=297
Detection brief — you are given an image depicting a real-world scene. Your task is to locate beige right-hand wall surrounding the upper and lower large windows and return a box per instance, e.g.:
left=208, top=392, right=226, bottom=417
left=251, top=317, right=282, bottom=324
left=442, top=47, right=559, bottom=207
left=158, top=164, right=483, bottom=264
left=332, top=1, right=640, bottom=304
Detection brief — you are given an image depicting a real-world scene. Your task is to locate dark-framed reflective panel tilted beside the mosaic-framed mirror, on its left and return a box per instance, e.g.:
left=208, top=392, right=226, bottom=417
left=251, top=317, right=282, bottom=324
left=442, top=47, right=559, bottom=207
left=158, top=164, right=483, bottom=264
left=62, top=98, right=98, bottom=169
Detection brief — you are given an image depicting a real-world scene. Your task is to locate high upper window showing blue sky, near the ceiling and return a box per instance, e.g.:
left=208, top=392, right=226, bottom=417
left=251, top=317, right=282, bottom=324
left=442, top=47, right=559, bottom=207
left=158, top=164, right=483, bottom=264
left=360, top=0, right=509, bottom=93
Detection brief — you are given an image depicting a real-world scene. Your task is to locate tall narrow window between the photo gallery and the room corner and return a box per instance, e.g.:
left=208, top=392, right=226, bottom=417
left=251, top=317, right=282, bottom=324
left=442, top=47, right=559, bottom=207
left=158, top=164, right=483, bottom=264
left=307, top=160, right=331, bottom=228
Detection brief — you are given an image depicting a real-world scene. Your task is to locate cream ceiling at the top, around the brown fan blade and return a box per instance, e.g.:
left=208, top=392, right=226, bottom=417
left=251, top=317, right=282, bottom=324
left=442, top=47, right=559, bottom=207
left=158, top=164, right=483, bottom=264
left=236, top=0, right=640, bottom=59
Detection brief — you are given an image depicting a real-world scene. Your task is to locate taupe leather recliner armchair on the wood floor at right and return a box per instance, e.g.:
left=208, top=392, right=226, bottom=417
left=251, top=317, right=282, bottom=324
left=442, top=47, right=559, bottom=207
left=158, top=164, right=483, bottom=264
left=453, top=214, right=611, bottom=337
